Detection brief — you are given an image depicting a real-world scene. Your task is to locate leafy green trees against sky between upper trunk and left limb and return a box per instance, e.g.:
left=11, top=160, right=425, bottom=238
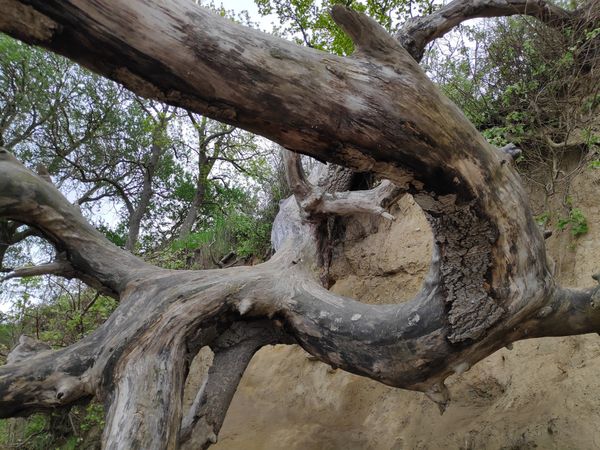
left=0, top=32, right=276, bottom=256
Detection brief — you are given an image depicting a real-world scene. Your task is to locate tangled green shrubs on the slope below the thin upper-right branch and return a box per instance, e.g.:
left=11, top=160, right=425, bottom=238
left=426, top=13, right=600, bottom=185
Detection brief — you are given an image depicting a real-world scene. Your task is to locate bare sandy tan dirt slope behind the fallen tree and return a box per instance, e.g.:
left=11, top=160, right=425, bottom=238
left=206, top=170, right=600, bottom=450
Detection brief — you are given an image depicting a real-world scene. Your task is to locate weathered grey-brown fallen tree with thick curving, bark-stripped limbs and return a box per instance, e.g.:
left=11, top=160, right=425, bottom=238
left=0, top=0, right=600, bottom=448
